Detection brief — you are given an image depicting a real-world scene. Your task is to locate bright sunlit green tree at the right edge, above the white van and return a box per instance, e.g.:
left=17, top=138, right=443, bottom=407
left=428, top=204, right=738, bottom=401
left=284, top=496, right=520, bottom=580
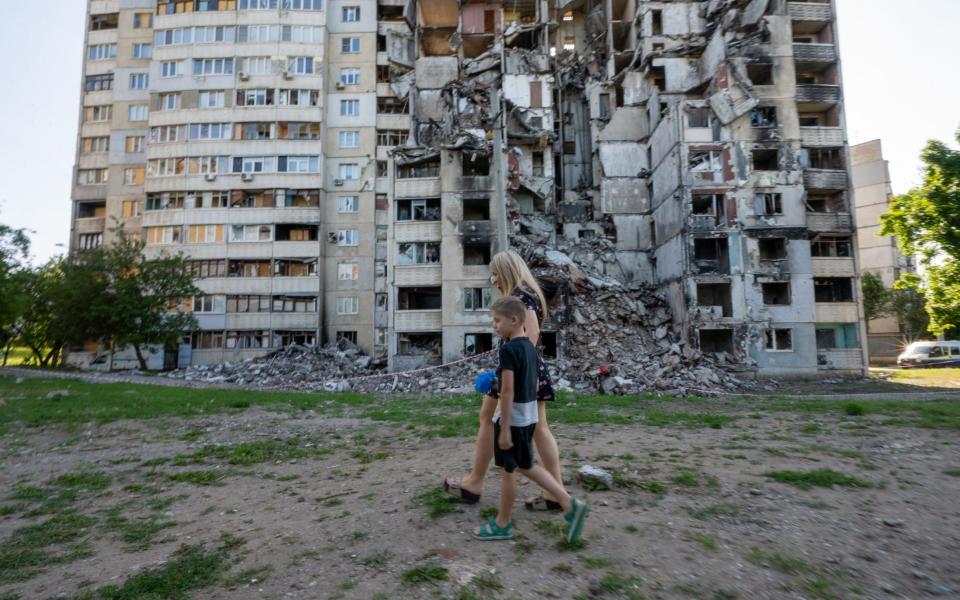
left=880, top=131, right=960, bottom=336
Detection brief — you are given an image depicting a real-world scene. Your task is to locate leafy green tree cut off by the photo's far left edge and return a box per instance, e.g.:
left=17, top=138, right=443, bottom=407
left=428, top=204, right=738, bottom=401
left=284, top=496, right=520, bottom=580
left=0, top=223, right=30, bottom=365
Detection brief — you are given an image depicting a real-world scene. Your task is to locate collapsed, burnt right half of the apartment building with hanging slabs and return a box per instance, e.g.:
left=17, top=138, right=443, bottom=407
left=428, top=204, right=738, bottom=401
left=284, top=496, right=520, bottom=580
left=387, top=0, right=866, bottom=375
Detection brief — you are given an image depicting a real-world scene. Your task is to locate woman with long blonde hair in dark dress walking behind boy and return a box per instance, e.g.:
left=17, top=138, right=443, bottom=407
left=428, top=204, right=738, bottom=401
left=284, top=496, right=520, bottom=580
left=443, top=250, right=563, bottom=510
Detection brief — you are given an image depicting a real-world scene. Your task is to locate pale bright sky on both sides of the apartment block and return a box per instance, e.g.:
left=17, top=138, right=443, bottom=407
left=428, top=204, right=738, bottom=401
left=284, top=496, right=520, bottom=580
left=0, top=0, right=960, bottom=262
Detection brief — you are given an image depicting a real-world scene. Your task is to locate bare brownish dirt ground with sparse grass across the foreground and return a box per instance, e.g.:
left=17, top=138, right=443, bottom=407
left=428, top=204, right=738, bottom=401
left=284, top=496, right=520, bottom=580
left=0, top=408, right=960, bottom=600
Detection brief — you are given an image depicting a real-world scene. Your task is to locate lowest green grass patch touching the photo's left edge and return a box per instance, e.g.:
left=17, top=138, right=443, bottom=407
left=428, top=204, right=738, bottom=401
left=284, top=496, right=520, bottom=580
left=0, top=512, right=97, bottom=585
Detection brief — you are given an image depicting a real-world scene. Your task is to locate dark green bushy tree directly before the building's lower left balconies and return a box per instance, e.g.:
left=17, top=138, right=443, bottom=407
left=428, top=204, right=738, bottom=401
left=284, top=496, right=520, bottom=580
left=98, top=229, right=199, bottom=369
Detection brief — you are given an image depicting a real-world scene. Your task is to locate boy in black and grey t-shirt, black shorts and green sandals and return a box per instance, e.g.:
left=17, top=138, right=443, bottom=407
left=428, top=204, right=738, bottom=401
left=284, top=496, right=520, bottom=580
left=473, top=296, right=587, bottom=542
